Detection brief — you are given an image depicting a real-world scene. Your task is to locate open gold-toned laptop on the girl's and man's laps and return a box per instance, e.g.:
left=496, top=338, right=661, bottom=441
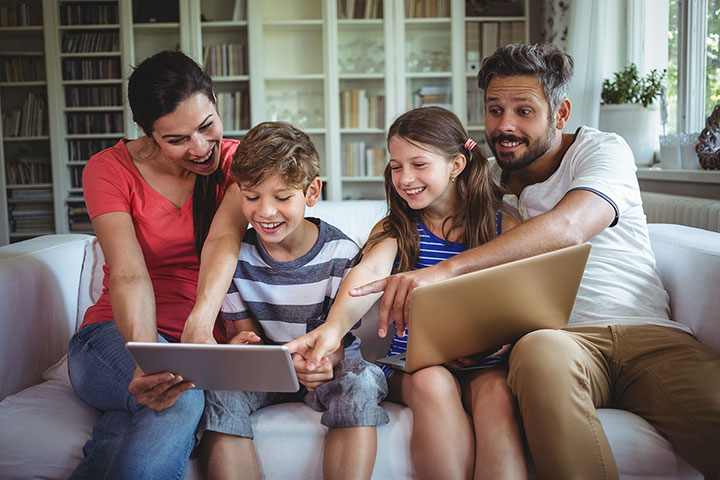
left=377, top=243, right=590, bottom=372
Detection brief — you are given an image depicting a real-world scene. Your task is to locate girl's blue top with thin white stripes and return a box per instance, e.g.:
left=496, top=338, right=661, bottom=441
left=380, top=211, right=502, bottom=378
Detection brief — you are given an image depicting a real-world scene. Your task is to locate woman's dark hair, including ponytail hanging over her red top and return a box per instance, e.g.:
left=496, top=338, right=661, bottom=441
left=128, top=50, right=225, bottom=258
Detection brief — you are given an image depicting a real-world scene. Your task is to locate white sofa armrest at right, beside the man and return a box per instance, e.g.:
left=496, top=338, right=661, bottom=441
left=648, top=223, right=720, bottom=352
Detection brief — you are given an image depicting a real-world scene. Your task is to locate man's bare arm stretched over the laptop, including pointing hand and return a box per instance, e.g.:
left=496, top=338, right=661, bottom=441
left=350, top=190, right=615, bottom=331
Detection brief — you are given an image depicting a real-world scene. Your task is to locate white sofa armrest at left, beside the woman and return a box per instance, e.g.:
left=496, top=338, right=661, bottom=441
left=0, top=235, right=93, bottom=399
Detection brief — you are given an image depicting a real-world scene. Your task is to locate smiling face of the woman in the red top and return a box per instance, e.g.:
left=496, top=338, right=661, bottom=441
left=152, top=93, right=223, bottom=175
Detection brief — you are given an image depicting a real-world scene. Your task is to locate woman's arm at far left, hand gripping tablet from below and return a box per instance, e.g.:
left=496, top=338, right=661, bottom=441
left=92, top=212, right=192, bottom=410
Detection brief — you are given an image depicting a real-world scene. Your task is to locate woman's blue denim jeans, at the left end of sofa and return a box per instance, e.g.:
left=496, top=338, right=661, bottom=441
left=68, top=321, right=205, bottom=479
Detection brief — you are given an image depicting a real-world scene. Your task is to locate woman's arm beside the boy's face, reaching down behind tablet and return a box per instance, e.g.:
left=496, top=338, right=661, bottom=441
left=180, top=184, right=247, bottom=343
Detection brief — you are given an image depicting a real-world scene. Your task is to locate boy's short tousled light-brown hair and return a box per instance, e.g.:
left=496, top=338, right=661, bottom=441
left=230, top=122, right=320, bottom=193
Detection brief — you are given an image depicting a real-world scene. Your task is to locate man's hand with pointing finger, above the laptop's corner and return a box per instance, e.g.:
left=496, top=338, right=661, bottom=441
left=349, top=262, right=451, bottom=338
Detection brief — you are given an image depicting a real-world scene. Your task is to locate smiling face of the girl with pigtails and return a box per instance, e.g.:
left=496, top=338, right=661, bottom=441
left=388, top=135, right=465, bottom=215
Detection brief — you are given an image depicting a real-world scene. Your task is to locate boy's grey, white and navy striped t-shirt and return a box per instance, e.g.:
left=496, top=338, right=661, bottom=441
left=220, top=218, right=360, bottom=347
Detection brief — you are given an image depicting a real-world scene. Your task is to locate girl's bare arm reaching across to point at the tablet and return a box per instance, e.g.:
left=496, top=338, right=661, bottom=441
left=287, top=220, right=397, bottom=371
